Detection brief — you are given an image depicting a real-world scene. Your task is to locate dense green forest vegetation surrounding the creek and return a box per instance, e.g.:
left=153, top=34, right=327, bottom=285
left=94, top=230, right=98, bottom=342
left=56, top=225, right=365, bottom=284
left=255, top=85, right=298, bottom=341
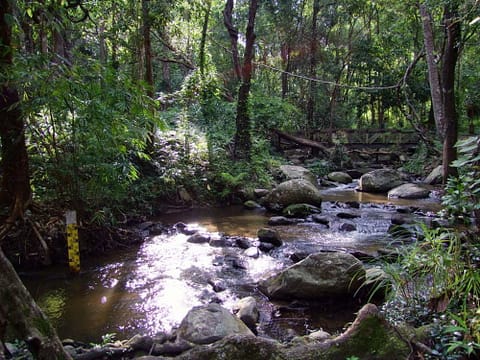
left=0, top=0, right=480, bottom=359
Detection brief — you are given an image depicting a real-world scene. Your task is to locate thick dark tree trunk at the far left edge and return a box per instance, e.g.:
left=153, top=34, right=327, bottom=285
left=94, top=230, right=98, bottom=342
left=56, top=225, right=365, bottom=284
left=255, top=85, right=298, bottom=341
left=0, top=0, right=31, bottom=225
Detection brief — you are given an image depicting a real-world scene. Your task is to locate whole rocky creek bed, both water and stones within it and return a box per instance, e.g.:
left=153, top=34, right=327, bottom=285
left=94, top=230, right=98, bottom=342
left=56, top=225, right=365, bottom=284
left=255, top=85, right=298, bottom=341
left=16, top=165, right=444, bottom=358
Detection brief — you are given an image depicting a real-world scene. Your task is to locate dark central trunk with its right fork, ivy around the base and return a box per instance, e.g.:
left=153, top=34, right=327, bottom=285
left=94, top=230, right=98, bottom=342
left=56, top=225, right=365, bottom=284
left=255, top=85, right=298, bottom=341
left=233, top=0, right=258, bottom=160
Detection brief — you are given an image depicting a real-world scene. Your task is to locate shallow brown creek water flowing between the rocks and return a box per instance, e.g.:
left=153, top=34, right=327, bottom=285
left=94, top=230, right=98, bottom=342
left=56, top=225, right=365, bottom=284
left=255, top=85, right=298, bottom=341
left=22, top=186, right=438, bottom=342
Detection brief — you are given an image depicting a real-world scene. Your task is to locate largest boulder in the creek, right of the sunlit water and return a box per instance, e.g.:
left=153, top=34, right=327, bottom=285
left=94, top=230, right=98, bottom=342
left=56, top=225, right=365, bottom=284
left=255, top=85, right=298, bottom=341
left=260, top=252, right=365, bottom=300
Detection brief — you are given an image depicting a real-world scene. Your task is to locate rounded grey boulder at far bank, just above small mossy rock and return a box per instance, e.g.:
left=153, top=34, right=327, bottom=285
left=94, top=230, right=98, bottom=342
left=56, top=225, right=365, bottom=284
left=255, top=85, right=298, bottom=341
left=262, top=179, right=322, bottom=211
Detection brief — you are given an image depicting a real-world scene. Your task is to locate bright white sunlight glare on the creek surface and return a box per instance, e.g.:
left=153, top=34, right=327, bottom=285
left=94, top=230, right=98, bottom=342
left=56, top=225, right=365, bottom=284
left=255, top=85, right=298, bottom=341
left=126, top=225, right=282, bottom=333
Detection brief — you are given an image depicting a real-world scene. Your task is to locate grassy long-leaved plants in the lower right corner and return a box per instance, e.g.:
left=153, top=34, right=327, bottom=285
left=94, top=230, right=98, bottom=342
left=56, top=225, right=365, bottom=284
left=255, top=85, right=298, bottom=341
left=384, top=225, right=480, bottom=359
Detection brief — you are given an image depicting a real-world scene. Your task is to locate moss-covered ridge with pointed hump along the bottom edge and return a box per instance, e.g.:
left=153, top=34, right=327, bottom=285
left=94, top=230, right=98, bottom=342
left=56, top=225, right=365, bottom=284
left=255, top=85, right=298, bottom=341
left=169, top=304, right=411, bottom=360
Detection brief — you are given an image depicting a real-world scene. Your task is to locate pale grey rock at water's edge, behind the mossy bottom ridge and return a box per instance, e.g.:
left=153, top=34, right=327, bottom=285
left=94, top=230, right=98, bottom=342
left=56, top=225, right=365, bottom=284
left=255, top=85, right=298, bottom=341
left=177, top=303, right=254, bottom=344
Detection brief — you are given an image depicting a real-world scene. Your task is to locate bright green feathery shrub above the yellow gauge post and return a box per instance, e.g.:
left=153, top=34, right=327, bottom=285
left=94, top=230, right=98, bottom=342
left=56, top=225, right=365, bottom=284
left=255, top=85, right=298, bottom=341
left=21, top=55, right=158, bottom=219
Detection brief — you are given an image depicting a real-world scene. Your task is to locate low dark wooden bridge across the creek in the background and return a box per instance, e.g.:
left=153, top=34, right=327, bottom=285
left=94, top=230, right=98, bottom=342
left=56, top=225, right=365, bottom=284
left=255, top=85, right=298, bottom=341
left=272, top=129, right=421, bottom=156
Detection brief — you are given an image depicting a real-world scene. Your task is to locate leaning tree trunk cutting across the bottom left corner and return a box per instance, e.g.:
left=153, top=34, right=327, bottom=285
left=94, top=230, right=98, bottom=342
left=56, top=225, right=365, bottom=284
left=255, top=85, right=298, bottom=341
left=0, top=249, right=71, bottom=360
